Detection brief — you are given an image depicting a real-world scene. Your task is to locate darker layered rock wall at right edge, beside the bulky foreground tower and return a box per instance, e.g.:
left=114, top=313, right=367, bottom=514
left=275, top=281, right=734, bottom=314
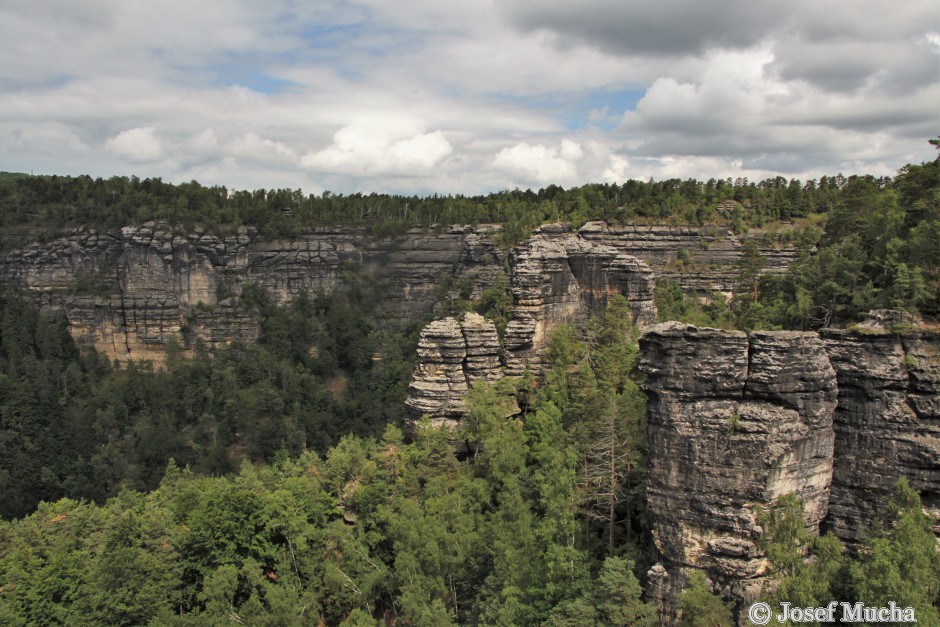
left=821, top=327, right=940, bottom=542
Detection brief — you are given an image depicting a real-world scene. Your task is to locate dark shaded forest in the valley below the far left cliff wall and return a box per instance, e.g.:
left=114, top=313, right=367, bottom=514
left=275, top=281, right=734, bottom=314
left=0, top=284, right=416, bottom=517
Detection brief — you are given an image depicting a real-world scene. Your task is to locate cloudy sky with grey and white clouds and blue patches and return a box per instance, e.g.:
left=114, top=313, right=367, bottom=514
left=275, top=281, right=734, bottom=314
left=0, top=0, right=940, bottom=194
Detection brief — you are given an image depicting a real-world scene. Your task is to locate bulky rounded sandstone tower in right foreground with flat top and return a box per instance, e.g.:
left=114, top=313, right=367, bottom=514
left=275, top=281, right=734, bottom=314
left=640, top=322, right=837, bottom=622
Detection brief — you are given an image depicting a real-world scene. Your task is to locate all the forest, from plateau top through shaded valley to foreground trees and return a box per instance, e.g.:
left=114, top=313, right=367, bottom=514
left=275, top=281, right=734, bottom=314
left=0, top=146, right=940, bottom=625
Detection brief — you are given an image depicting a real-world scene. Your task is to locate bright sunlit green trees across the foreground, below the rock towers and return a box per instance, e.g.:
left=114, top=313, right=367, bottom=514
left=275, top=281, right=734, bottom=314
left=0, top=300, right=940, bottom=626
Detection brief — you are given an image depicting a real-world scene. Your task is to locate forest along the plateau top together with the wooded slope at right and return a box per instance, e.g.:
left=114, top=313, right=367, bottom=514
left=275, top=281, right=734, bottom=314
left=0, top=140, right=940, bottom=329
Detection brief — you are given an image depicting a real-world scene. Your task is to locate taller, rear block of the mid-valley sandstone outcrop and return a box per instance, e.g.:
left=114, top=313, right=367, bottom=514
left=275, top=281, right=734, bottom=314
left=505, top=225, right=656, bottom=375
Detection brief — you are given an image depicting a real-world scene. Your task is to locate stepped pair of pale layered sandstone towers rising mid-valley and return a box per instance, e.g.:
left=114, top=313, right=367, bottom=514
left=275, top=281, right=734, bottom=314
left=406, top=225, right=656, bottom=427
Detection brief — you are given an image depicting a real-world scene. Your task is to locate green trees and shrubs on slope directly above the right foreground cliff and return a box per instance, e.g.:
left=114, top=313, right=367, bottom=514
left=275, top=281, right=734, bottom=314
left=656, top=152, right=940, bottom=330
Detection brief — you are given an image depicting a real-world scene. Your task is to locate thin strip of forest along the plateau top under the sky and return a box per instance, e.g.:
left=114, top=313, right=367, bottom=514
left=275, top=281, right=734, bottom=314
left=0, top=156, right=938, bottom=249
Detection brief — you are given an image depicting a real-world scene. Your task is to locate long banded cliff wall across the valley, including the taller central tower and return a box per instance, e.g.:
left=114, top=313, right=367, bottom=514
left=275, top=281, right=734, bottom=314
left=0, top=222, right=792, bottom=370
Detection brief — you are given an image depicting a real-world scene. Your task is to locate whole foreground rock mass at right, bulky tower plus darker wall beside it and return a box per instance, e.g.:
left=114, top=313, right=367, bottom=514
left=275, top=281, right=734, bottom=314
left=640, top=322, right=940, bottom=622
